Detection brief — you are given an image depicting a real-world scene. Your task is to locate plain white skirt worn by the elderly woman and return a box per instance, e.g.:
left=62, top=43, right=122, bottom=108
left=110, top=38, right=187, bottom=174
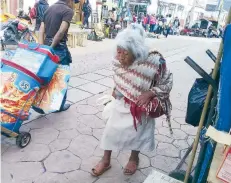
left=100, top=98, right=155, bottom=151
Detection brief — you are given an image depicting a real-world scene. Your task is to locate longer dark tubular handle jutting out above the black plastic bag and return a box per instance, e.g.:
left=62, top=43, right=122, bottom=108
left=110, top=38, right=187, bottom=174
left=184, top=57, right=218, bottom=91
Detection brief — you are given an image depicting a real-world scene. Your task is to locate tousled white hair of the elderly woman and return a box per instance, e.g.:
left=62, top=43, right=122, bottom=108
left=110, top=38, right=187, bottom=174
left=116, top=24, right=149, bottom=61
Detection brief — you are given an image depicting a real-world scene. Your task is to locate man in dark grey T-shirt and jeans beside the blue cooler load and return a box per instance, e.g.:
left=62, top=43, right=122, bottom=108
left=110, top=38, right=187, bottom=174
left=39, top=0, right=74, bottom=112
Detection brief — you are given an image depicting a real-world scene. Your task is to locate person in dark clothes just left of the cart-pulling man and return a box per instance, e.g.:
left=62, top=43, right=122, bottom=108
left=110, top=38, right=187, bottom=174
left=35, top=0, right=49, bottom=32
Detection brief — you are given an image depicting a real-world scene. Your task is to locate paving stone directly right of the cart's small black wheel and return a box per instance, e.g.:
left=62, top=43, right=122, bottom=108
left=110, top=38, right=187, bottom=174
left=31, top=128, right=59, bottom=144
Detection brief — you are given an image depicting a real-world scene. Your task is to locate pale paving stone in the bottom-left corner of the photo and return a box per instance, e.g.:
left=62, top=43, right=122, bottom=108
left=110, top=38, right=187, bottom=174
left=1, top=162, right=44, bottom=183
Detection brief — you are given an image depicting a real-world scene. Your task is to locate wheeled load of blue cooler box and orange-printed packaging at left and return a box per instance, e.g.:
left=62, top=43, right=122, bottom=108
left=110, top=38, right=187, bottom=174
left=0, top=43, right=59, bottom=147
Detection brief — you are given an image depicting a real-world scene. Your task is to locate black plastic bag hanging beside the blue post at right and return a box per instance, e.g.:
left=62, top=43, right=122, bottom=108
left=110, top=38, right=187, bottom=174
left=185, top=78, right=209, bottom=126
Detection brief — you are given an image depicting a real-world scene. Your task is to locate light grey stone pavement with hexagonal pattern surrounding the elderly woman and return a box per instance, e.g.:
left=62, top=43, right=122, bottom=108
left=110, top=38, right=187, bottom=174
left=1, top=36, right=219, bottom=183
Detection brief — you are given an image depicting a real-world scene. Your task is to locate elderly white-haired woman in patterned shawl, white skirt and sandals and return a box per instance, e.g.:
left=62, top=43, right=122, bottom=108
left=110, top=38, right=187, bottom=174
left=92, top=24, right=172, bottom=176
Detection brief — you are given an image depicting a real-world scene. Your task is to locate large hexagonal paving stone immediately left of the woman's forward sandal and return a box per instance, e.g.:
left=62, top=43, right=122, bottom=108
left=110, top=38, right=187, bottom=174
left=44, top=150, right=81, bottom=173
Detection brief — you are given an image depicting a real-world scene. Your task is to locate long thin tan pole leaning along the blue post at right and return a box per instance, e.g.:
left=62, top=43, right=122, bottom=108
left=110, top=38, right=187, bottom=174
left=184, top=8, right=231, bottom=183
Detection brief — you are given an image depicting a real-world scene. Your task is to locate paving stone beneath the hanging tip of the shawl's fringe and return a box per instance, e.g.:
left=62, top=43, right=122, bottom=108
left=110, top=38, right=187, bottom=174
left=158, top=127, right=187, bottom=140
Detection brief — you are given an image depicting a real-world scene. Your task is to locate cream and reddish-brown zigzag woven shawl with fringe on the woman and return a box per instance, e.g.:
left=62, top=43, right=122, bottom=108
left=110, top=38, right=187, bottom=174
left=113, top=51, right=172, bottom=133
